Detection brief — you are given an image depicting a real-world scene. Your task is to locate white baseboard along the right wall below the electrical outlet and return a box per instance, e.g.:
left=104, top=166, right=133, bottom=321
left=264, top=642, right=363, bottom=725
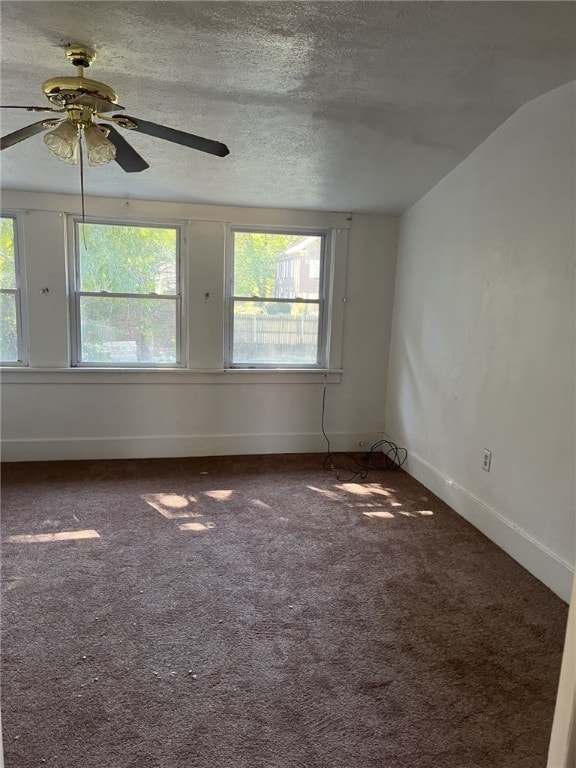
left=403, top=452, right=574, bottom=602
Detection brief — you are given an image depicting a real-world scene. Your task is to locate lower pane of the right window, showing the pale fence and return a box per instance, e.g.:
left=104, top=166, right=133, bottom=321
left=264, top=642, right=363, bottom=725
left=232, top=301, right=319, bottom=365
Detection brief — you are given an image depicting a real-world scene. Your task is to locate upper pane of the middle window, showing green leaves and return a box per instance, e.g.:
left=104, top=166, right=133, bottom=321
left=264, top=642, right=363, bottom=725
left=78, top=223, right=177, bottom=295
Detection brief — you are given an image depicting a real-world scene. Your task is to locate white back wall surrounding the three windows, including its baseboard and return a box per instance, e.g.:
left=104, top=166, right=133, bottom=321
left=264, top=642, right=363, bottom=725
left=1, top=192, right=397, bottom=461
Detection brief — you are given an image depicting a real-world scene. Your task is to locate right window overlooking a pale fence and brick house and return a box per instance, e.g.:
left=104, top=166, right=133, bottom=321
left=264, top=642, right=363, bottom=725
left=227, top=229, right=330, bottom=368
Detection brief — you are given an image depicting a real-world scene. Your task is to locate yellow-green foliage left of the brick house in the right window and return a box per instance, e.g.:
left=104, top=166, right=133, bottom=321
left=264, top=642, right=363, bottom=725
left=234, top=232, right=302, bottom=299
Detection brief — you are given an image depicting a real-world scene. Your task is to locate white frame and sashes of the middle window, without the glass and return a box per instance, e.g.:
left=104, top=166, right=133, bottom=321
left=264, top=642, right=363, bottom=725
left=68, top=216, right=187, bottom=370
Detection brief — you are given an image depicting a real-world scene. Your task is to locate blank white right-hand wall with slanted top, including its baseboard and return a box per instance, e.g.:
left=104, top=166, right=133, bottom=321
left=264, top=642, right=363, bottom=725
left=386, top=84, right=576, bottom=600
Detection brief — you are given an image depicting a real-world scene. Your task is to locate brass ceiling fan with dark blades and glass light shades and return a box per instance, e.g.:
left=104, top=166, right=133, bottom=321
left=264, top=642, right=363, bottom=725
left=0, top=44, right=229, bottom=173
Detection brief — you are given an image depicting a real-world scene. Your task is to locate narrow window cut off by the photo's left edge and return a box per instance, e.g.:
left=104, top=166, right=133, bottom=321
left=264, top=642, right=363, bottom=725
left=0, top=216, right=26, bottom=365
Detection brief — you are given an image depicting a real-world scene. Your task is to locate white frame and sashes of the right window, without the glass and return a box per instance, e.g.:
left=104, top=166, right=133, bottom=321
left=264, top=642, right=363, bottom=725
left=224, top=224, right=335, bottom=370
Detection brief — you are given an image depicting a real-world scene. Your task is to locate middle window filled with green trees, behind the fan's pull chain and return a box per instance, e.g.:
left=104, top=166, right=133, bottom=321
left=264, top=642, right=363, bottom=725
left=72, top=221, right=182, bottom=367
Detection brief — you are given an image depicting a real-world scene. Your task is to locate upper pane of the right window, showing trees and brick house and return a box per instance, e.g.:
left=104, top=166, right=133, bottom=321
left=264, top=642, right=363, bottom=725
left=234, top=232, right=323, bottom=299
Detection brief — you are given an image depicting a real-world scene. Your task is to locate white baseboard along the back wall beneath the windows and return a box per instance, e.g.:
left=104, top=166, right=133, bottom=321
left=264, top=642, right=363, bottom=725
left=1, top=432, right=382, bottom=462
